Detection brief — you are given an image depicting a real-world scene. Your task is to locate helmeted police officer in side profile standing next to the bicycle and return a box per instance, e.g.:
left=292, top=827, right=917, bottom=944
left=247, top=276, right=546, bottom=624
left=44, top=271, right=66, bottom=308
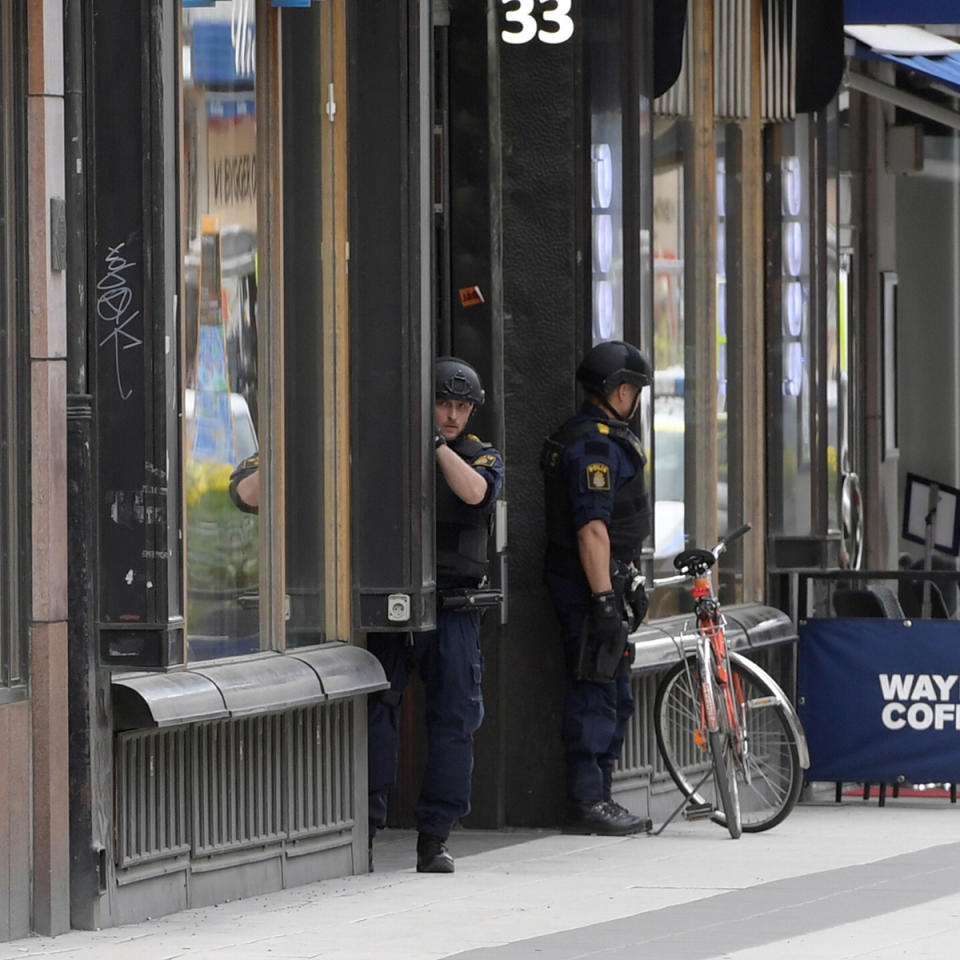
left=541, top=340, right=653, bottom=835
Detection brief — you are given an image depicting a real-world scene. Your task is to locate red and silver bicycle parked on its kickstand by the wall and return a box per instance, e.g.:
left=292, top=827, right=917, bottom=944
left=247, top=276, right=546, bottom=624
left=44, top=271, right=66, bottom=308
left=653, top=524, right=810, bottom=839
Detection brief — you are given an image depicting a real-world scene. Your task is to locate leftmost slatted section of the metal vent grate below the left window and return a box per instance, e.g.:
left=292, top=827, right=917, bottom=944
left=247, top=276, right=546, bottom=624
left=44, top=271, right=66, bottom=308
left=115, top=730, right=190, bottom=867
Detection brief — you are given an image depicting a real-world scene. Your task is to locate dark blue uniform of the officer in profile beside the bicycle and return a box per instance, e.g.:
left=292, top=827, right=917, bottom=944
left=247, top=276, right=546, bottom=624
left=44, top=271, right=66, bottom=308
left=545, top=401, right=650, bottom=804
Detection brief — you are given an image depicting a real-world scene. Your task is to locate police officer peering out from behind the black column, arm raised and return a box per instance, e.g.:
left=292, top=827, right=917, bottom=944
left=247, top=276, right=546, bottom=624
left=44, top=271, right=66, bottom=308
left=367, top=357, right=503, bottom=873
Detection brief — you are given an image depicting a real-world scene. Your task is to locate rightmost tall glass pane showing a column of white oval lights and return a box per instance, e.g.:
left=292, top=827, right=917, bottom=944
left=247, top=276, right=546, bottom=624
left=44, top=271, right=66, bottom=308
left=765, top=102, right=844, bottom=584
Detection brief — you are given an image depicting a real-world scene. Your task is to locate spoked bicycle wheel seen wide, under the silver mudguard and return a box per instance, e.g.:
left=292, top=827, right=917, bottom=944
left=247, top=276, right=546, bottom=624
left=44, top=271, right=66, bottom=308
left=654, top=657, right=803, bottom=833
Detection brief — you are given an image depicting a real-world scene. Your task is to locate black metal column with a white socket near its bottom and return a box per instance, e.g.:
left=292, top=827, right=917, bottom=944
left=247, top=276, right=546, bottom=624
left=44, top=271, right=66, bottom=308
left=348, top=0, right=435, bottom=630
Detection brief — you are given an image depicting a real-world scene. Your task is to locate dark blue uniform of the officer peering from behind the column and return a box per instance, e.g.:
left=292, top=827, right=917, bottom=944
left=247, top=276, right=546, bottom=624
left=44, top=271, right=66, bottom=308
left=367, top=435, right=503, bottom=840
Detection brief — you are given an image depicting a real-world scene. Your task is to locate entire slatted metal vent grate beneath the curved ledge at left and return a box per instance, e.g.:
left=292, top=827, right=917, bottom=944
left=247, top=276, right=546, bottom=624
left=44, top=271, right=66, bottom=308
left=115, top=700, right=355, bottom=868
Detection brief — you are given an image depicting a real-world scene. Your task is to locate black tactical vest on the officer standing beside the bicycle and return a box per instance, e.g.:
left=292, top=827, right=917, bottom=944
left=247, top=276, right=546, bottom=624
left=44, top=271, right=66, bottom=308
left=540, top=420, right=650, bottom=580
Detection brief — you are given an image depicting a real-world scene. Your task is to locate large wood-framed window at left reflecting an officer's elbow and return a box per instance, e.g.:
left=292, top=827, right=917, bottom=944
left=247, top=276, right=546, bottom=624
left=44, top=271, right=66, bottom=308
left=181, top=0, right=349, bottom=660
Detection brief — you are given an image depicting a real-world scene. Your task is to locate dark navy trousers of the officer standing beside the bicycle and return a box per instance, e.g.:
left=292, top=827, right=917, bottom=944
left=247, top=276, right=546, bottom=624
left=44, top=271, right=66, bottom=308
left=546, top=573, right=634, bottom=803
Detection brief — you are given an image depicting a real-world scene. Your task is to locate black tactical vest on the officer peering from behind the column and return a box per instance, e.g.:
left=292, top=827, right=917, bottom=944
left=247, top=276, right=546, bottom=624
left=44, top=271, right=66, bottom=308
left=437, top=434, right=492, bottom=586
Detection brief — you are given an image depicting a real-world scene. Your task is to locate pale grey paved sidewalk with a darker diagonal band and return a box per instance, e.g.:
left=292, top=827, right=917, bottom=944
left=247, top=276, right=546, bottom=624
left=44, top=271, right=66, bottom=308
left=0, top=798, right=960, bottom=960
